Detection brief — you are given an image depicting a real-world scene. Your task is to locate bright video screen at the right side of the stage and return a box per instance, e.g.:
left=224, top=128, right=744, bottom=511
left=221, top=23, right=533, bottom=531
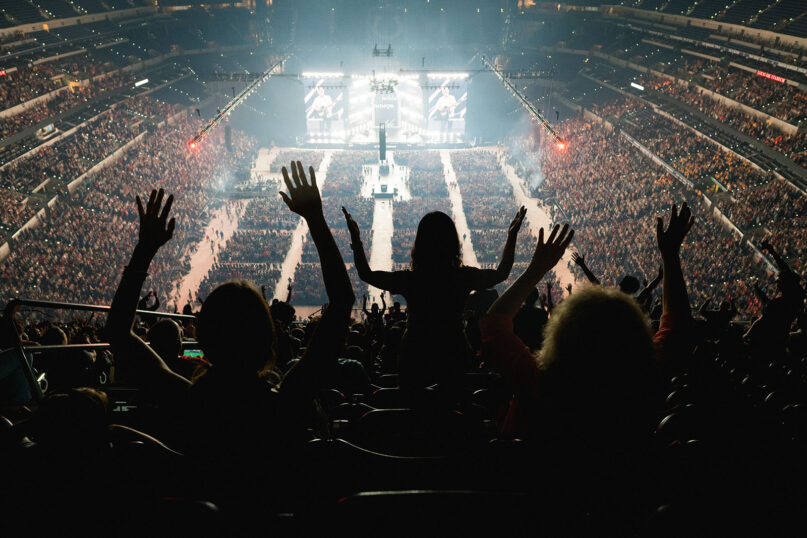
left=426, top=73, right=468, bottom=142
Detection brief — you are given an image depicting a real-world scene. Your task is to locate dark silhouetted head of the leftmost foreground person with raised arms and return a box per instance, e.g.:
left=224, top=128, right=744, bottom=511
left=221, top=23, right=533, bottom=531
left=196, top=280, right=275, bottom=375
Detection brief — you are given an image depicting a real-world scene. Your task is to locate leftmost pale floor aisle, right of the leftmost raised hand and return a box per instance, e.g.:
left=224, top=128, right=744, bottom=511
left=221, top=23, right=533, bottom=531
left=169, top=200, right=247, bottom=311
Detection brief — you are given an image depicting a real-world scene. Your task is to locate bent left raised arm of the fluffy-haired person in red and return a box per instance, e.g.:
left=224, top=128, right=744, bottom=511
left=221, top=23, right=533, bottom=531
left=488, top=224, right=574, bottom=319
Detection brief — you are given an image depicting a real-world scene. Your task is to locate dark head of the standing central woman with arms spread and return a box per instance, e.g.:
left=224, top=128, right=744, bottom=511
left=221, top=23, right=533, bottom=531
left=411, top=211, right=462, bottom=271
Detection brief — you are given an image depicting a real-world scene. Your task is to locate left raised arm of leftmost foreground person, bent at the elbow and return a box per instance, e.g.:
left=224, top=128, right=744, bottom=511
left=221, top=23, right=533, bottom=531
left=105, top=189, right=190, bottom=399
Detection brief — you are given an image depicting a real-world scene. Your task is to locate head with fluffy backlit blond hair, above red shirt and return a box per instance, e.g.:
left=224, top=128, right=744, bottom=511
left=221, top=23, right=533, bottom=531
left=538, top=286, right=658, bottom=441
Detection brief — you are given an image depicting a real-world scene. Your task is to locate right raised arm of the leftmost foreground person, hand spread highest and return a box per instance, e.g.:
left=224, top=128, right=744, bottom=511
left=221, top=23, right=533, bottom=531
left=280, top=161, right=356, bottom=400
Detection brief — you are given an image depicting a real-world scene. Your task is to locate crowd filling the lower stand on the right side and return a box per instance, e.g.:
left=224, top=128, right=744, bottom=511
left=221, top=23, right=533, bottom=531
left=536, top=120, right=772, bottom=317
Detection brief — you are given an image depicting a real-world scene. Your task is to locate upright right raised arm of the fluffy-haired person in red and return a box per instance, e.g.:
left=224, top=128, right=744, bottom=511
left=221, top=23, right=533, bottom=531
left=656, top=202, right=695, bottom=320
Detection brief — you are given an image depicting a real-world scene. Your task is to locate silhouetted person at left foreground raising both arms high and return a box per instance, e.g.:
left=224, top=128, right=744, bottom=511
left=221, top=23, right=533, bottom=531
left=106, top=161, right=355, bottom=510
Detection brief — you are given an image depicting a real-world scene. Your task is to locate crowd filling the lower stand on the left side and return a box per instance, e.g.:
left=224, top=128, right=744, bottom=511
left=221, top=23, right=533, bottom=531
left=0, top=117, right=254, bottom=304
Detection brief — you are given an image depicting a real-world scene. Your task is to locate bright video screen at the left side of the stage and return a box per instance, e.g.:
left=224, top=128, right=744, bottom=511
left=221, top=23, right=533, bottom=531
left=302, top=73, right=346, bottom=141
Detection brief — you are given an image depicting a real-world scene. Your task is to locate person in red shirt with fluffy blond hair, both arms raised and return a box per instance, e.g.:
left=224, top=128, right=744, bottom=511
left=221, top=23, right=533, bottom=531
left=480, top=203, right=694, bottom=444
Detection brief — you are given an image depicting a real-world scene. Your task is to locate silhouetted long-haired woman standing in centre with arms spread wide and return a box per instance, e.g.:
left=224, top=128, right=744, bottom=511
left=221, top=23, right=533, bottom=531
left=342, top=207, right=527, bottom=389
